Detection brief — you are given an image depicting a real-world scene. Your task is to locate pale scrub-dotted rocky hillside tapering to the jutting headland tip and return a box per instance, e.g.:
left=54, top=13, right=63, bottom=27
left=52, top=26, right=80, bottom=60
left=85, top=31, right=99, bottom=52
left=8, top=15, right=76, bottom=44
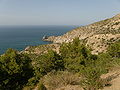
left=44, top=14, right=120, bottom=54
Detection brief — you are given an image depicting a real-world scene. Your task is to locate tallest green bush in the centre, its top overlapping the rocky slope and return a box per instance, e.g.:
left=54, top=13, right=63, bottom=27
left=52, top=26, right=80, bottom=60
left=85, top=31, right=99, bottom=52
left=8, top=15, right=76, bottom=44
left=60, top=38, right=95, bottom=72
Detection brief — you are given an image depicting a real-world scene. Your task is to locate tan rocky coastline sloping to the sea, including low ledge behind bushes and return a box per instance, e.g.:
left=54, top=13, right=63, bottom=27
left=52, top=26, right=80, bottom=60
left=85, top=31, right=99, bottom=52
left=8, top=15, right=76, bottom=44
left=22, top=14, right=120, bottom=55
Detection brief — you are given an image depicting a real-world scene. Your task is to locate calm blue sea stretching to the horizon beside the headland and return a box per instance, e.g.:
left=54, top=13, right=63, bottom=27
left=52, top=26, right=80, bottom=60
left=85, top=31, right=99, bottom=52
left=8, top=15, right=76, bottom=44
left=0, top=26, right=75, bottom=54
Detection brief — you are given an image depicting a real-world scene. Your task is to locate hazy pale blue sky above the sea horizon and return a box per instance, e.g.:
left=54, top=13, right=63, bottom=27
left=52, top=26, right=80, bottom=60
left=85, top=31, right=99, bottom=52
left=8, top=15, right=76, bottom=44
left=0, top=0, right=120, bottom=25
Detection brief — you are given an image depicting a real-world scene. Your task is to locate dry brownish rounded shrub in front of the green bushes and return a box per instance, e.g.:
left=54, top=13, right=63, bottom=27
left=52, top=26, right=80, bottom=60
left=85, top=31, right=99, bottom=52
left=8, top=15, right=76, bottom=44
left=42, top=71, right=80, bottom=90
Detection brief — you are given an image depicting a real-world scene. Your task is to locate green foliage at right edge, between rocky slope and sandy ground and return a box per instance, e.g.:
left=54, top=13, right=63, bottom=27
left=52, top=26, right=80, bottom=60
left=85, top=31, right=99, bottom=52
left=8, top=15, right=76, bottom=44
left=96, top=42, right=120, bottom=72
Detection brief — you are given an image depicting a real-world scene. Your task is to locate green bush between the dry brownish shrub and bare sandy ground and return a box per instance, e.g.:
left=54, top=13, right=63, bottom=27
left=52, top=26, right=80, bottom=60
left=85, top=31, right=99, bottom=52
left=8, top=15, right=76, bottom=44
left=80, top=61, right=104, bottom=90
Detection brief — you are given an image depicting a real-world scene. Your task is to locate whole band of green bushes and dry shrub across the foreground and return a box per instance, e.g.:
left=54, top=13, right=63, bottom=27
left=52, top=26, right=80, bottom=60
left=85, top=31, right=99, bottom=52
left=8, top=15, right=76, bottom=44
left=0, top=38, right=120, bottom=90
